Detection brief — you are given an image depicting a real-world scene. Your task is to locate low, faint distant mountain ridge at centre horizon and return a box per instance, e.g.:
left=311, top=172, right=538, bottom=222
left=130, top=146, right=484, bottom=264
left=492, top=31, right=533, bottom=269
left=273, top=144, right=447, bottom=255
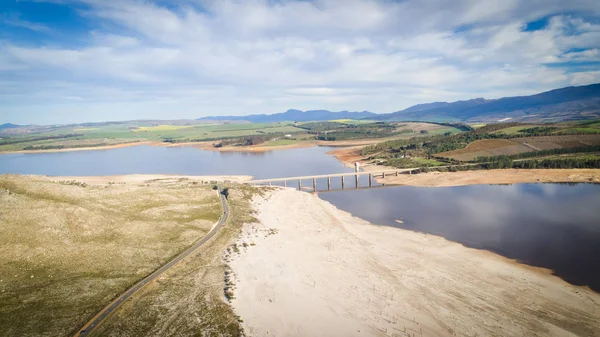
left=198, top=109, right=377, bottom=123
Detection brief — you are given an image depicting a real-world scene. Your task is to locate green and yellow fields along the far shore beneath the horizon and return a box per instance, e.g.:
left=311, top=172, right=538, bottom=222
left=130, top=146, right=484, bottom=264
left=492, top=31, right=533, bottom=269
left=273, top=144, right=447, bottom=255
left=0, top=119, right=460, bottom=152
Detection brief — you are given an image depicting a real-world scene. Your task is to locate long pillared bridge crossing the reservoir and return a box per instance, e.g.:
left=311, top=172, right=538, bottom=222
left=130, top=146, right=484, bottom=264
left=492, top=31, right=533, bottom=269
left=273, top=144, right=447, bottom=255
left=247, top=168, right=418, bottom=192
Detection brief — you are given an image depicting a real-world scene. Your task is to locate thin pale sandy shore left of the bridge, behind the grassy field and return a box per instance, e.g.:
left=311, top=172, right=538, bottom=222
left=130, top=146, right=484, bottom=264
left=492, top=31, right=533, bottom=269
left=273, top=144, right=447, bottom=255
left=39, top=174, right=252, bottom=184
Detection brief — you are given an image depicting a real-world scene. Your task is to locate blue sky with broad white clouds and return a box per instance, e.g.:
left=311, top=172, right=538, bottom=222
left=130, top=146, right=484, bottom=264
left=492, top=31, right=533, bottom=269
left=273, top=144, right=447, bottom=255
left=0, top=0, right=600, bottom=124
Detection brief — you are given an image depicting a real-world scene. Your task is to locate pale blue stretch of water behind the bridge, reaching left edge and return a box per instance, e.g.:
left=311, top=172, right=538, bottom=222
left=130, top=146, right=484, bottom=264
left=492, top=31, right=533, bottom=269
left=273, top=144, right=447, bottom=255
left=0, top=146, right=353, bottom=179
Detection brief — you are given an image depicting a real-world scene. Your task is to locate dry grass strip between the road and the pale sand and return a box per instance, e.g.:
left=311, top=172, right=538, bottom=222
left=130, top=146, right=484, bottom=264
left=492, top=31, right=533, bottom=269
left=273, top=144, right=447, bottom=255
left=92, top=185, right=260, bottom=337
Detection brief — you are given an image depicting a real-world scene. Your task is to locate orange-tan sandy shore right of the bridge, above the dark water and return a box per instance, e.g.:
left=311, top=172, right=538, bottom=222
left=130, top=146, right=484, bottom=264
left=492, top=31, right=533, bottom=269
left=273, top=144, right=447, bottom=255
left=377, top=169, right=600, bottom=187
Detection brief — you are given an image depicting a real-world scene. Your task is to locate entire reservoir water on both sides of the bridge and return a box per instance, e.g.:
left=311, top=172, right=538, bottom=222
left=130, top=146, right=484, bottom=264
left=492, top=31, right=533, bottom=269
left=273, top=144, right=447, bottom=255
left=0, top=145, right=600, bottom=292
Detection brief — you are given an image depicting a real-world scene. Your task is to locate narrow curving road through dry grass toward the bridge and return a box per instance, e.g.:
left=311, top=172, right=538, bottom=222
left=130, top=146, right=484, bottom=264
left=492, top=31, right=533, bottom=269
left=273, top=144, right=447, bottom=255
left=75, top=184, right=229, bottom=337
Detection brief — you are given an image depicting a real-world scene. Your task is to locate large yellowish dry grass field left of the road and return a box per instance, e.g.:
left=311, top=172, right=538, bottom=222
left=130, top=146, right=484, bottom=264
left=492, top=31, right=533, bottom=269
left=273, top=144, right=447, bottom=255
left=0, top=175, right=229, bottom=336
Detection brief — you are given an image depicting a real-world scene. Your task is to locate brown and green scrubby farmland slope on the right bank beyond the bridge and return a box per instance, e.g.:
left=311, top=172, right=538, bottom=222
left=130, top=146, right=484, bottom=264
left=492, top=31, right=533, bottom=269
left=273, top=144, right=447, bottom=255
left=361, top=120, right=600, bottom=170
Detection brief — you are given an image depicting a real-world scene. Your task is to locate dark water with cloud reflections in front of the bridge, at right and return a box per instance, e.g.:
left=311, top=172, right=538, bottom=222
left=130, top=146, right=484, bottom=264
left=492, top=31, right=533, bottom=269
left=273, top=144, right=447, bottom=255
left=320, top=184, right=600, bottom=292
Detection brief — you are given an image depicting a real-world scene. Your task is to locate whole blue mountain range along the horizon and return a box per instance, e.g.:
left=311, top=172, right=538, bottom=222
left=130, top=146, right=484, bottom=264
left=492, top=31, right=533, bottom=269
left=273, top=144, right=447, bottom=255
left=199, top=83, right=600, bottom=123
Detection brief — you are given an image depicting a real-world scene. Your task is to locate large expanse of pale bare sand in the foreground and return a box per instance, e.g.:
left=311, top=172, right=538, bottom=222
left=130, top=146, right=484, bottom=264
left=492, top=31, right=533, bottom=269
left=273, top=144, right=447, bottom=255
left=230, top=189, right=600, bottom=336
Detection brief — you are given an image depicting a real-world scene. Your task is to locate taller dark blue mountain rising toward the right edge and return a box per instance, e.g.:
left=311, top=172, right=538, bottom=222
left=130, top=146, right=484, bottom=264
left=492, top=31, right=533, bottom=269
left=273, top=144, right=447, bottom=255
left=374, top=83, right=600, bottom=122
